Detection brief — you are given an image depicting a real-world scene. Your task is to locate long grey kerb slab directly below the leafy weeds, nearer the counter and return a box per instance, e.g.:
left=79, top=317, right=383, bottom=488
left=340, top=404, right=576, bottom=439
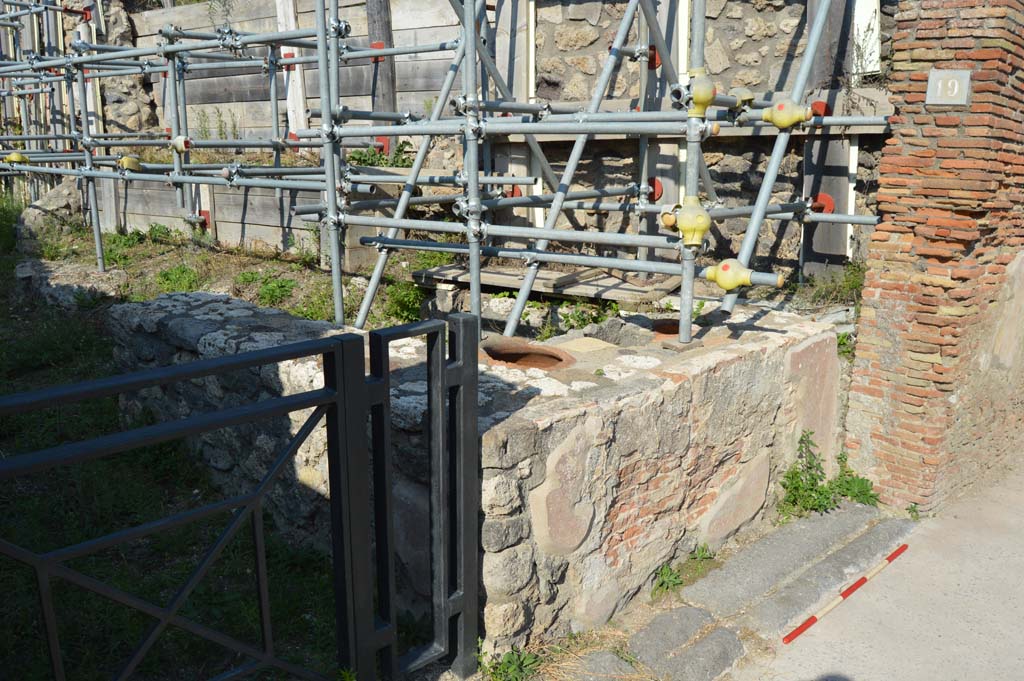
left=682, top=505, right=879, bottom=618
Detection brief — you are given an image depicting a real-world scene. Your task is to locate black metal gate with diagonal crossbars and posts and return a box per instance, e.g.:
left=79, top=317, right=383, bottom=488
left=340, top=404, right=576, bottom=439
left=0, top=314, right=479, bottom=681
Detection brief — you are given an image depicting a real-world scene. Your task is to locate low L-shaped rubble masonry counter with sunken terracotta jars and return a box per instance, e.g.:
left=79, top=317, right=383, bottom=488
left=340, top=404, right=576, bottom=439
left=99, top=286, right=840, bottom=648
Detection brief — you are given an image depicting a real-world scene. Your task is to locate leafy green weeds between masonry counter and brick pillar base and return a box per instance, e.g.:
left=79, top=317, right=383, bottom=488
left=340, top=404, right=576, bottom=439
left=778, top=430, right=879, bottom=521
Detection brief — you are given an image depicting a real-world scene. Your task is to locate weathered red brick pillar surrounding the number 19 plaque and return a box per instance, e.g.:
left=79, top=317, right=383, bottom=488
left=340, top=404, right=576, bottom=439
left=847, top=0, right=1024, bottom=509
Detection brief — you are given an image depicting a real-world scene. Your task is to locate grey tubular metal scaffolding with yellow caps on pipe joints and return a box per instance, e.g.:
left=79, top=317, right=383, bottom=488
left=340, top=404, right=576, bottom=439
left=0, top=0, right=887, bottom=343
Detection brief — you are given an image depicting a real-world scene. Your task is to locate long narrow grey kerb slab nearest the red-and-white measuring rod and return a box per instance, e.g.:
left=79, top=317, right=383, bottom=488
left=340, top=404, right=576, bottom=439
left=744, top=519, right=913, bottom=637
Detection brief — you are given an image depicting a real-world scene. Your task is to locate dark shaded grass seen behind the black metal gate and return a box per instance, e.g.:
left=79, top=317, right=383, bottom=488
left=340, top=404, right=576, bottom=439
left=0, top=222, right=341, bottom=681
